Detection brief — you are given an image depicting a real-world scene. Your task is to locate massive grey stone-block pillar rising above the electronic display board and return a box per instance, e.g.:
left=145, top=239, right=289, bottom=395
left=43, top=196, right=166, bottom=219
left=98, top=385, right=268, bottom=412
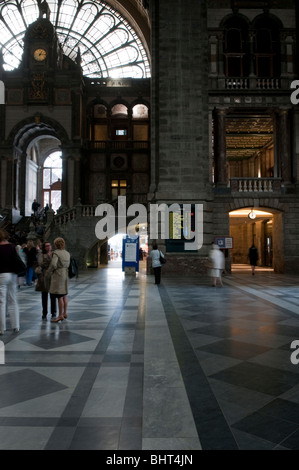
left=150, top=0, right=210, bottom=202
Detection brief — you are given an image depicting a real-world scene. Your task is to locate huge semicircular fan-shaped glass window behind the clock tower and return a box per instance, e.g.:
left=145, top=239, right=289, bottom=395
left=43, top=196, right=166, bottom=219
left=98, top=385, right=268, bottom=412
left=0, top=0, right=150, bottom=78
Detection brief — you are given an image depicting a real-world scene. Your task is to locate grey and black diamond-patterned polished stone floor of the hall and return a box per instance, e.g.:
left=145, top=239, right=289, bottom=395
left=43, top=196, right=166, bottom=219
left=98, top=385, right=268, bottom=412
left=0, top=267, right=299, bottom=451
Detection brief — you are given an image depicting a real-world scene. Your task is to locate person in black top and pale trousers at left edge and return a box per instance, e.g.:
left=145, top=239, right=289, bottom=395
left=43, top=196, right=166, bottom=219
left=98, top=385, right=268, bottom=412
left=0, top=229, right=20, bottom=335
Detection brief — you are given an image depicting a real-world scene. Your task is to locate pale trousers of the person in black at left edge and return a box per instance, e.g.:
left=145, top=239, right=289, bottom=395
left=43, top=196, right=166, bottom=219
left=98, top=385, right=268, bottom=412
left=0, top=273, right=20, bottom=333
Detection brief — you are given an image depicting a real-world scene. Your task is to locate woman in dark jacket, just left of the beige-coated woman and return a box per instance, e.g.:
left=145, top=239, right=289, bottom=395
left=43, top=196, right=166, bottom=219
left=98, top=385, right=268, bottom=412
left=35, top=242, right=56, bottom=320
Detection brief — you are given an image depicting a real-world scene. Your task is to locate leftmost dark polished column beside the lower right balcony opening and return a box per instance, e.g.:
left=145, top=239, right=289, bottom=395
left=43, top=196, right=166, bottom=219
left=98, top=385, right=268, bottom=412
left=214, top=109, right=227, bottom=186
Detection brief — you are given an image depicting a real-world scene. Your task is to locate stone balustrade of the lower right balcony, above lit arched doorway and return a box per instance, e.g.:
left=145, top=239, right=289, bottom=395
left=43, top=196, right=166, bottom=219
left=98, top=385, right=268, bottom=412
left=230, top=178, right=281, bottom=193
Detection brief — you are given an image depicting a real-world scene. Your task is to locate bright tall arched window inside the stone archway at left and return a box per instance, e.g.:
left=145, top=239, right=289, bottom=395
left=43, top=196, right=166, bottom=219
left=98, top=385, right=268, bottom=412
left=43, top=152, right=62, bottom=211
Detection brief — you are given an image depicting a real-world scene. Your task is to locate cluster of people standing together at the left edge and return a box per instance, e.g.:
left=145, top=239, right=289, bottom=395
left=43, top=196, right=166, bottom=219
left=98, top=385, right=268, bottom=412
left=0, top=229, right=70, bottom=335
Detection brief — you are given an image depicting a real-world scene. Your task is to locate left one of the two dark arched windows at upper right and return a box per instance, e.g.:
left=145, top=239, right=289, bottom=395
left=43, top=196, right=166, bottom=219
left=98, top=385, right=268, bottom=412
left=223, top=16, right=250, bottom=77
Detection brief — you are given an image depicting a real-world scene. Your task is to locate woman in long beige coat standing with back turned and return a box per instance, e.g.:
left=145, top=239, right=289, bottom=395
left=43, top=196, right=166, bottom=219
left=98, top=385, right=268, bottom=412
left=46, top=238, right=71, bottom=322
